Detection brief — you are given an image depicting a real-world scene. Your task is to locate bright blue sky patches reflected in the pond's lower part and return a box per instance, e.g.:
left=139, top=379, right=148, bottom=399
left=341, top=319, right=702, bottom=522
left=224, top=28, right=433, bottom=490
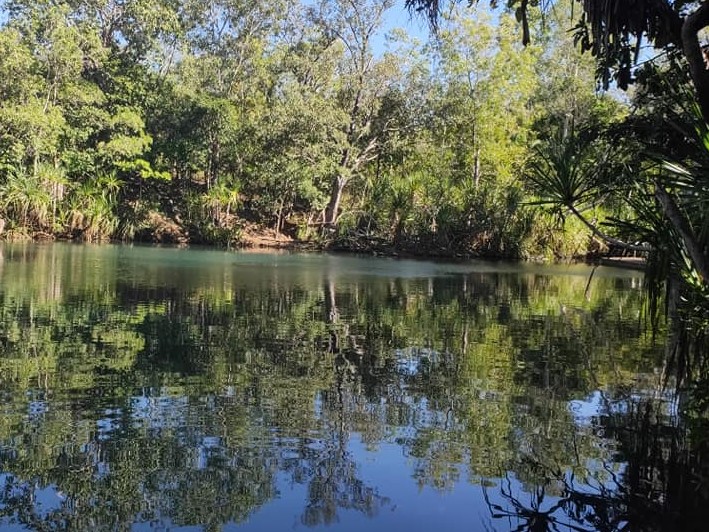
left=74, top=388, right=625, bottom=532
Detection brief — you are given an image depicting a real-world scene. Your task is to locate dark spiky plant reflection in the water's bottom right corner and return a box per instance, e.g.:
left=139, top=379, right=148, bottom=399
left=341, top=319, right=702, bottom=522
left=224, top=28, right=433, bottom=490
left=483, top=397, right=709, bottom=531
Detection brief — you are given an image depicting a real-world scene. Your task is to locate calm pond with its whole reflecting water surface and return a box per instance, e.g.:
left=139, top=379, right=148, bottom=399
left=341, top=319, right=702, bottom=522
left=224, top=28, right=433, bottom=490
left=0, top=244, right=706, bottom=531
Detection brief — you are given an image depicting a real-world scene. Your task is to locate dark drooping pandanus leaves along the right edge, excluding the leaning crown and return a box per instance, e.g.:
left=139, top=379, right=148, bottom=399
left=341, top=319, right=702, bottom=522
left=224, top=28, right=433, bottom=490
left=631, top=104, right=709, bottom=382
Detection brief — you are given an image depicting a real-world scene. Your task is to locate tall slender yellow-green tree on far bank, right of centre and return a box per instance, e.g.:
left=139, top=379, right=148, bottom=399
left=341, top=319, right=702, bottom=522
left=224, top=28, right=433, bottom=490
left=440, top=6, right=541, bottom=255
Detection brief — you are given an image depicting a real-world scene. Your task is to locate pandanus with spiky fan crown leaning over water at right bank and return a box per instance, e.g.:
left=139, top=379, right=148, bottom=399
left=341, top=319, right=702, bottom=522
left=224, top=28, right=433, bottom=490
left=526, top=106, right=709, bottom=383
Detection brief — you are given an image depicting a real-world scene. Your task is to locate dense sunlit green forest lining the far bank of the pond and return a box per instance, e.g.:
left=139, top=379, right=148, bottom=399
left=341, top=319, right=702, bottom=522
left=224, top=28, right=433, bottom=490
left=0, top=0, right=632, bottom=257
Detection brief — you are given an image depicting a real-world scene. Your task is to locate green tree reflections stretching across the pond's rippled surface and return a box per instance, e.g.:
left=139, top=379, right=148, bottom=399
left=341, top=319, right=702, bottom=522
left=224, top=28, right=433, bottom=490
left=0, top=244, right=680, bottom=528
